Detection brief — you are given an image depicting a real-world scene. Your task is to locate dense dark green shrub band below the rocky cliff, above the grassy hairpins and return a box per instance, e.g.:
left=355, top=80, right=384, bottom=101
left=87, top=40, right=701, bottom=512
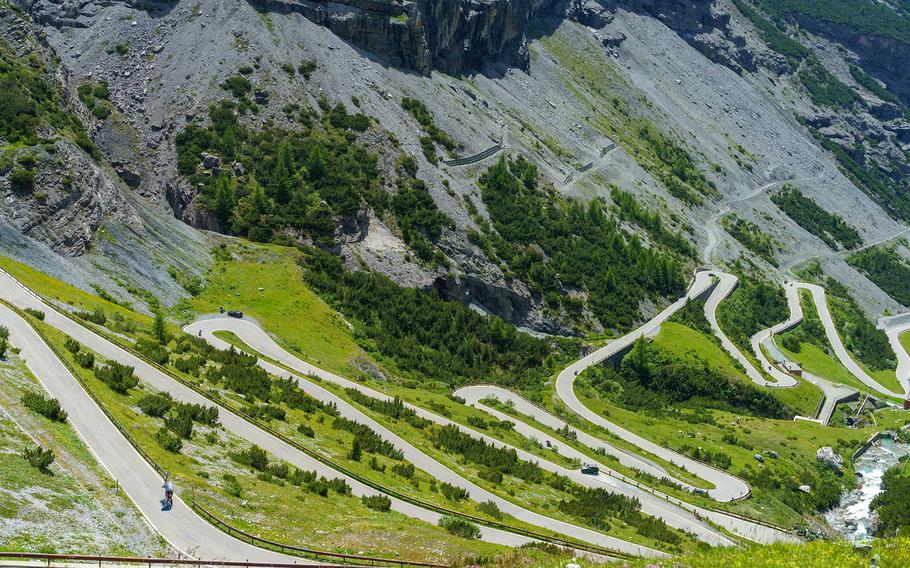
left=303, top=242, right=559, bottom=387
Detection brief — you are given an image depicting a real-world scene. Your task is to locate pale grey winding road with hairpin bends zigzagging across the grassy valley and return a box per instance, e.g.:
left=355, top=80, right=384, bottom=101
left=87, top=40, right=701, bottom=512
left=0, top=255, right=896, bottom=558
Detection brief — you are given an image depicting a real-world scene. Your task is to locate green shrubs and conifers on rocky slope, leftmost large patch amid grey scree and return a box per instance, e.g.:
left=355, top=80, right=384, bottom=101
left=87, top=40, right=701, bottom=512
left=176, top=98, right=452, bottom=263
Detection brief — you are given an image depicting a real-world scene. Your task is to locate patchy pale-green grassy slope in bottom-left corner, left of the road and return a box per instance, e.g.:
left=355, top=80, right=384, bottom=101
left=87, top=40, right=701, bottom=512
left=0, top=350, right=169, bottom=556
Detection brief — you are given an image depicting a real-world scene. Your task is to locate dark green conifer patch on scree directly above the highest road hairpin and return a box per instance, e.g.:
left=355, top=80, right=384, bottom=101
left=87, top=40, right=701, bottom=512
left=473, top=156, right=685, bottom=328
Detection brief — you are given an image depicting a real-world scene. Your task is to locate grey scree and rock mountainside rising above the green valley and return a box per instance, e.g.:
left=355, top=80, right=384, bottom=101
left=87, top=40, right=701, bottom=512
left=7, top=0, right=906, bottom=333
